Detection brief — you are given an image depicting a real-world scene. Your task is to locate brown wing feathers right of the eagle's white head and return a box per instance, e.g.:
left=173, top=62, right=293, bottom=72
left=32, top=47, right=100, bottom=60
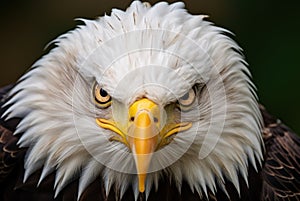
left=261, top=107, right=300, bottom=201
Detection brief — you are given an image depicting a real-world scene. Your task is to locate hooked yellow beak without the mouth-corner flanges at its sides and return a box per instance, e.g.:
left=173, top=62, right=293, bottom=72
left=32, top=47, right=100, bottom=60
left=127, top=98, right=160, bottom=192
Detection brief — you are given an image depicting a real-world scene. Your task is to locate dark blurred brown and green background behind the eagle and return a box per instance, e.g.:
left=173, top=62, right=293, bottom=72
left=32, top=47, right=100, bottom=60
left=0, top=0, right=300, bottom=133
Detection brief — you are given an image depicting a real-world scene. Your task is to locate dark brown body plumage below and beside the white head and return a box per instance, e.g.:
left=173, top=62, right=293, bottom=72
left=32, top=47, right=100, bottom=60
left=0, top=86, right=300, bottom=201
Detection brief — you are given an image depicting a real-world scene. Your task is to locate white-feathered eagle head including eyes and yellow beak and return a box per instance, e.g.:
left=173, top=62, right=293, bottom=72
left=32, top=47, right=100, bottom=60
left=5, top=1, right=263, bottom=198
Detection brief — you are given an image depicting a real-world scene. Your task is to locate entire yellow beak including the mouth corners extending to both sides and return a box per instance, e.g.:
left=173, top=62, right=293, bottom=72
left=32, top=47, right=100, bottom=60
left=96, top=98, right=191, bottom=192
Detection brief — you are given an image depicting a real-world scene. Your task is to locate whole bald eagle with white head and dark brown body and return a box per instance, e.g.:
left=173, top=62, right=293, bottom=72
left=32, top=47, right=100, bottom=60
left=0, top=1, right=300, bottom=201
